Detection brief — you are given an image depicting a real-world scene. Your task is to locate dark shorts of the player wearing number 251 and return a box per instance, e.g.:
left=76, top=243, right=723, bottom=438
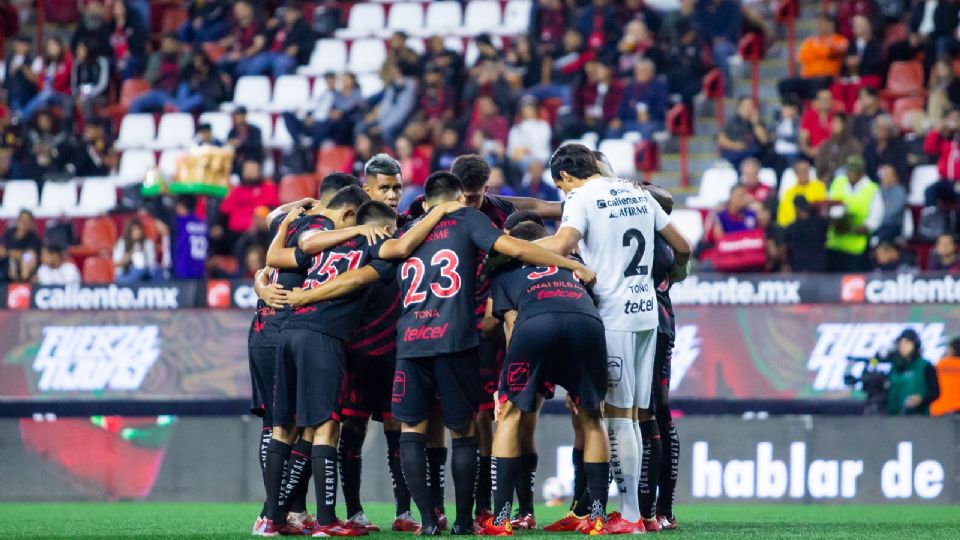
left=273, top=328, right=346, bottom=427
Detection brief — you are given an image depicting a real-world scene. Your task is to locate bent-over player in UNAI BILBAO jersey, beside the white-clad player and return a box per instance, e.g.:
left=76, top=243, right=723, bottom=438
left=480, top=222, right=610, bottom=536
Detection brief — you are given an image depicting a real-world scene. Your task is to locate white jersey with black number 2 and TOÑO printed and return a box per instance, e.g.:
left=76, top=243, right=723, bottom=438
left=560, top=178, right=670, bottom=332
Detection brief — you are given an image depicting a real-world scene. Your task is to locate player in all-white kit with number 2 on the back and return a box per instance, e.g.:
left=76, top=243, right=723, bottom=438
left=542, top=144, right=692, bottom=533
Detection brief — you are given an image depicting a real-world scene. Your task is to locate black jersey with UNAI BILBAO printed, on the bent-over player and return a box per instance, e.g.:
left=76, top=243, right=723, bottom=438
left=490, top=266, right=600, bottom=326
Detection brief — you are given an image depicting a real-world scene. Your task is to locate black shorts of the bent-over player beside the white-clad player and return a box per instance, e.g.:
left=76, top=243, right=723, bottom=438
left=500, top=313, right=607, bottom=412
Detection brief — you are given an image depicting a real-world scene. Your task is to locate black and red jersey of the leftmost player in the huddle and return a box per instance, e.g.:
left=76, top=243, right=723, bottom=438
left=250, top=215, right=334, bottom=347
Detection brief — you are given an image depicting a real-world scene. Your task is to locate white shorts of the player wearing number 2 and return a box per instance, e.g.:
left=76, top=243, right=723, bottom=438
left=605, top=329, right=657, bottom=409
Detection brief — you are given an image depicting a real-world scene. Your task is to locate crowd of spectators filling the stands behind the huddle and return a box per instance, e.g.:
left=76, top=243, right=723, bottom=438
left=0, top=0, right=960, bottom=283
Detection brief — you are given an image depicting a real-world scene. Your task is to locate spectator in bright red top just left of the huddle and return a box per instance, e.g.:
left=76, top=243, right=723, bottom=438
left=210, top=159, right=280, bottom=255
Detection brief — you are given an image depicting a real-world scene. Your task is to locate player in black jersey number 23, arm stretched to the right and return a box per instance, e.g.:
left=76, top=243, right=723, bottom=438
left=380, top=172, right=594, bottom=536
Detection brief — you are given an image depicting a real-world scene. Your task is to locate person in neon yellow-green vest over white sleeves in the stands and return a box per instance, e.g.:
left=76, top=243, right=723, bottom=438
left=827, top=155, right=883, bottom=272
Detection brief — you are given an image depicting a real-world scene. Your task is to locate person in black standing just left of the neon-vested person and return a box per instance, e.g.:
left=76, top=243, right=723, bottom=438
left=777, top=196, right=830, bottom=272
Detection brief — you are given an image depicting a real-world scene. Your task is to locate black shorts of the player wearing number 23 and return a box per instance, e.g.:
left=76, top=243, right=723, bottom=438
left=392, top=349, right=482, bottom=431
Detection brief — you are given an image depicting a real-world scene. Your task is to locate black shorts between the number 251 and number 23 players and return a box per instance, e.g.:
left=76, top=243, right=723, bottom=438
left=342, top=354, right=397, bottom=422
